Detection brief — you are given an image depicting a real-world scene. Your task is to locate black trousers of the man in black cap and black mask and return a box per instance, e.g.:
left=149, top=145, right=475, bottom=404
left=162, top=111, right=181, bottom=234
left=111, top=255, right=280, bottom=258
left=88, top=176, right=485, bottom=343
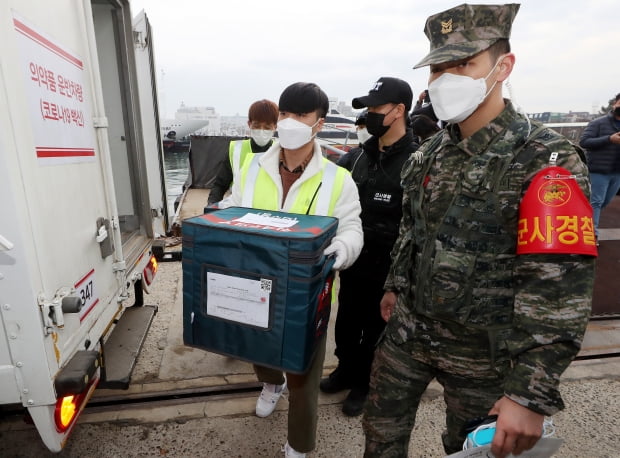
left=334, top=248, right=389, bottom=391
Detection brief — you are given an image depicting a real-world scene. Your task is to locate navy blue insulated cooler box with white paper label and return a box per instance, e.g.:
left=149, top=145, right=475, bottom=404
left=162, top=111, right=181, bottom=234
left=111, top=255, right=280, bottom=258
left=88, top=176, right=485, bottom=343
left=182, top=207, right=338, bottom=373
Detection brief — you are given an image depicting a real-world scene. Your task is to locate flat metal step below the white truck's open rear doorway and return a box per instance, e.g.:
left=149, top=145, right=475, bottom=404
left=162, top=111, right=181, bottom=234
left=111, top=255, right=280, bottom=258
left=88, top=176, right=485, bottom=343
left=99, top=305, right=157, bottom=390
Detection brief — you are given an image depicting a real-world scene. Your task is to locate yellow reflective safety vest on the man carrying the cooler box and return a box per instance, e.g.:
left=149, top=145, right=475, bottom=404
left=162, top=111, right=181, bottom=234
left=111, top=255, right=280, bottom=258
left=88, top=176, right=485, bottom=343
left=239, top=153, right=348, bottom=216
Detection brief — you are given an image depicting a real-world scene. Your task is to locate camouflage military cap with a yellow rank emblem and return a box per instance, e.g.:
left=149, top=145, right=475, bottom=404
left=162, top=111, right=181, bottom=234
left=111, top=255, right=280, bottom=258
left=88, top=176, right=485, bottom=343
left=413, top=3, right=521, bottom=68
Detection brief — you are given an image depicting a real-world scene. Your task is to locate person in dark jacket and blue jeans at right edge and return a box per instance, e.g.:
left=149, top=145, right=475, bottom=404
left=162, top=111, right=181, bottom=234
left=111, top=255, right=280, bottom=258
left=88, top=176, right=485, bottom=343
left=579, top=93, right=620, bottom=238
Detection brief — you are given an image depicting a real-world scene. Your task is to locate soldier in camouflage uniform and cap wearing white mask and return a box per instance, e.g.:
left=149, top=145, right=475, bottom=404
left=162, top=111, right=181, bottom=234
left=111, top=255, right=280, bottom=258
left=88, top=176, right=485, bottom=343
left=363, top=4, right=596, bottom=458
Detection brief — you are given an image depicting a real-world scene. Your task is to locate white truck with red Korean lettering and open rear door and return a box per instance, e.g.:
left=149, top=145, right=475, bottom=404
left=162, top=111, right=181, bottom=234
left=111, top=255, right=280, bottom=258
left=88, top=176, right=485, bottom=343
left=0, top=0, right=168, bottom=452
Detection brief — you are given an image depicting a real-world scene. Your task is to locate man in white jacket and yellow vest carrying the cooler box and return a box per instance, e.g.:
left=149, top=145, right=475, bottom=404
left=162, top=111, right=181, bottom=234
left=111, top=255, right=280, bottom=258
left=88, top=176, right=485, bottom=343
left=223, top=82, right=363, bottom=457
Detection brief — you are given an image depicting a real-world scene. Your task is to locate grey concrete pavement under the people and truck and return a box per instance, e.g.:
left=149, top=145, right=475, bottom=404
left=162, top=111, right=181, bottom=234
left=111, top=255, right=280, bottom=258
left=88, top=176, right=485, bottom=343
left=0, top=262, right=620, bottom=458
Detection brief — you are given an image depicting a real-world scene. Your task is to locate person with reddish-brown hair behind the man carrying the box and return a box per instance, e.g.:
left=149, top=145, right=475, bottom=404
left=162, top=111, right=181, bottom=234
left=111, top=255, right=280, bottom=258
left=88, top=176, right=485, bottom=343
left=208, top=99, right=278, bottom=205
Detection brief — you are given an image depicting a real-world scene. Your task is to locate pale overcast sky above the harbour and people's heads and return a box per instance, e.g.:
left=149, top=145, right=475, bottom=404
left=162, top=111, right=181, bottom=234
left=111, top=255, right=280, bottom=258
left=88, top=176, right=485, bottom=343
left=131, top=0, right=620, bottom=117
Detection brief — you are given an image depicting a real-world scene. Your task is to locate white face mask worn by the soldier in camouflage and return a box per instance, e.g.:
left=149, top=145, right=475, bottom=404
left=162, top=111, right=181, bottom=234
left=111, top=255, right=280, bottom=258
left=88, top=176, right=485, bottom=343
left=428, top=56, right=504, bottom=123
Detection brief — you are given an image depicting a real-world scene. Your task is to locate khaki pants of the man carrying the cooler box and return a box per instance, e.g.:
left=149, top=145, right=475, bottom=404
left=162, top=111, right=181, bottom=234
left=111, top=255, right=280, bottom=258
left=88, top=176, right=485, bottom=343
left=254, top=333, right=327, bottom=453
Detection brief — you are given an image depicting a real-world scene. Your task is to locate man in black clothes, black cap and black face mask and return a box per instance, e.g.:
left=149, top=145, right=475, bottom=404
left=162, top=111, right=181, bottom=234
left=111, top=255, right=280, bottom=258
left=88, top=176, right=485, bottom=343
left=320, top=77, right=418, bottom=416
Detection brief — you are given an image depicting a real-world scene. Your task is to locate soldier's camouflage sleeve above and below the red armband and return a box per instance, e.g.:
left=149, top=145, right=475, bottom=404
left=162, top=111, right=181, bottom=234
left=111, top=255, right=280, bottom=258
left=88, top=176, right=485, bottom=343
left=504, top=132, right=595, bottom=415
